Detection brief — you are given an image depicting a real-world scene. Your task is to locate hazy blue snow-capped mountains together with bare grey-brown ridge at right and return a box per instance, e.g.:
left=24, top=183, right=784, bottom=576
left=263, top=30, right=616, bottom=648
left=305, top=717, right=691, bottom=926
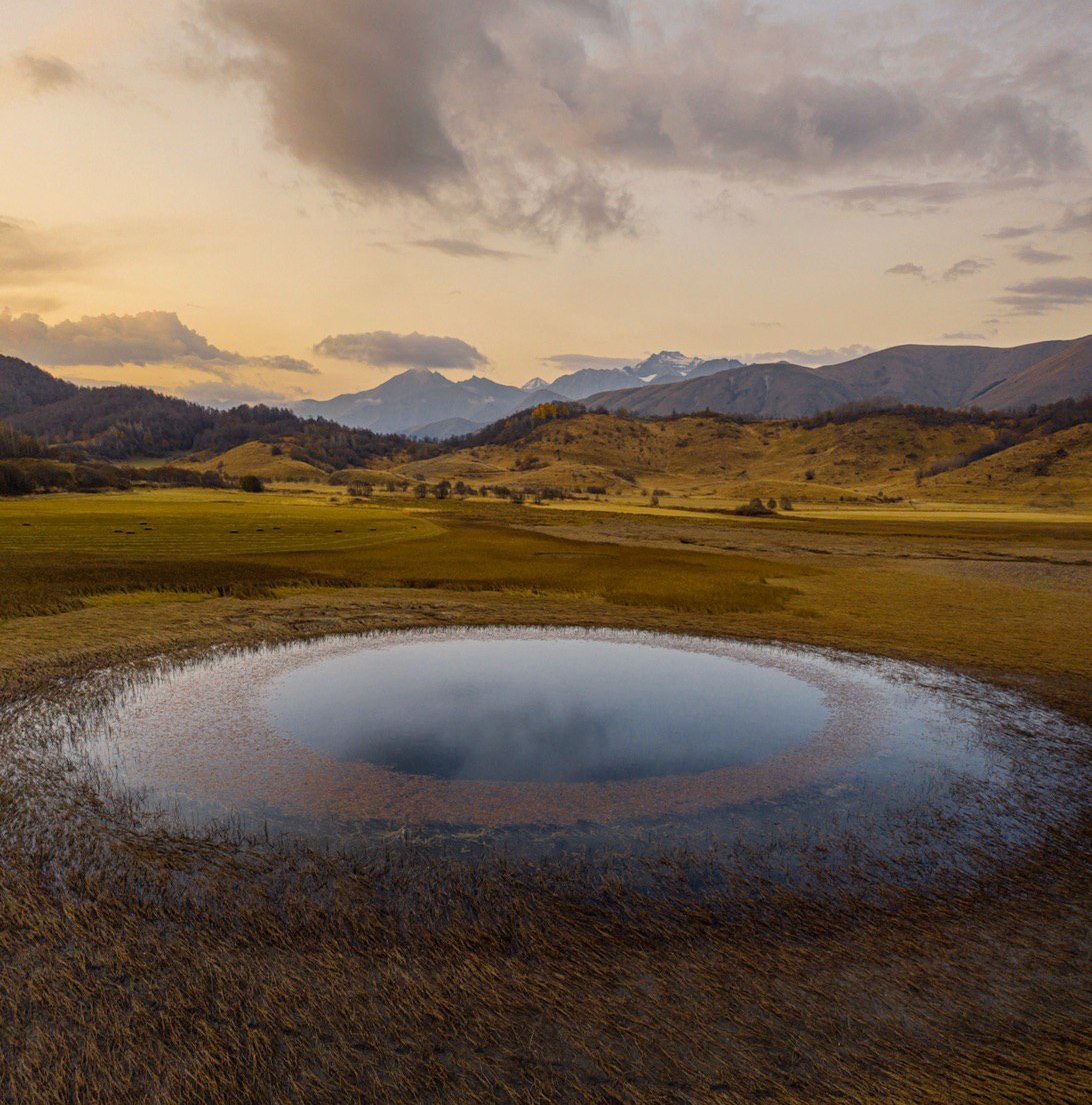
left=295, top=337, right=1092, bottom=439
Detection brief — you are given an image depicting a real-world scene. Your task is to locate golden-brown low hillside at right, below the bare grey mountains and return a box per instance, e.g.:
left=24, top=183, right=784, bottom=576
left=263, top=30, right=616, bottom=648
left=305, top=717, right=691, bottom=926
left=398, top=412, right=1092, bottom=505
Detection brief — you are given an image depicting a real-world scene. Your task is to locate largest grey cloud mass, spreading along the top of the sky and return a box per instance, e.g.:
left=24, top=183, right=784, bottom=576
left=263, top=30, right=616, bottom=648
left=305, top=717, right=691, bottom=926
left=202, top=0, right=1086, bottom=239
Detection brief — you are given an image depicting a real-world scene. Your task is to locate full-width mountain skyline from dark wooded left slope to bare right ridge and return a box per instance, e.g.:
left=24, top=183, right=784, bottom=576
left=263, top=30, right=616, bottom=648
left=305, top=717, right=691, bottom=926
left=0, top=336, right=1092, bottom=463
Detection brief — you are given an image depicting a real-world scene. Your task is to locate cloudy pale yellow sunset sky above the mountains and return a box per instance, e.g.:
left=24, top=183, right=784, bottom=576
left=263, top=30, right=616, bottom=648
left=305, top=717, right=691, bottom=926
left=0, top=0, right=1092, bottom=404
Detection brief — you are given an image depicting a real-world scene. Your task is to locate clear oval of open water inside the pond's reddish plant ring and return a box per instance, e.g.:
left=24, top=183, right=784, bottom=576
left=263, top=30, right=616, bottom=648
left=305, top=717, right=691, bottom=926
left=264, top=638, right=828, bottom=782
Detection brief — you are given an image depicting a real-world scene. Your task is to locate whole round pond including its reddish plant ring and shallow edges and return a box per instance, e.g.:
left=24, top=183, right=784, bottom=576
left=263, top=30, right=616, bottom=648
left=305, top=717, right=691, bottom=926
left=84, top=629, right=1088, bottom=872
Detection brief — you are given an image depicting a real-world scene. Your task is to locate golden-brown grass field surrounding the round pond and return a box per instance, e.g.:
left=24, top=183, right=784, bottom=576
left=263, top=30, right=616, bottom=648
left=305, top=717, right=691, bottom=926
left=0, top=486, right=1092, bottom=1105
